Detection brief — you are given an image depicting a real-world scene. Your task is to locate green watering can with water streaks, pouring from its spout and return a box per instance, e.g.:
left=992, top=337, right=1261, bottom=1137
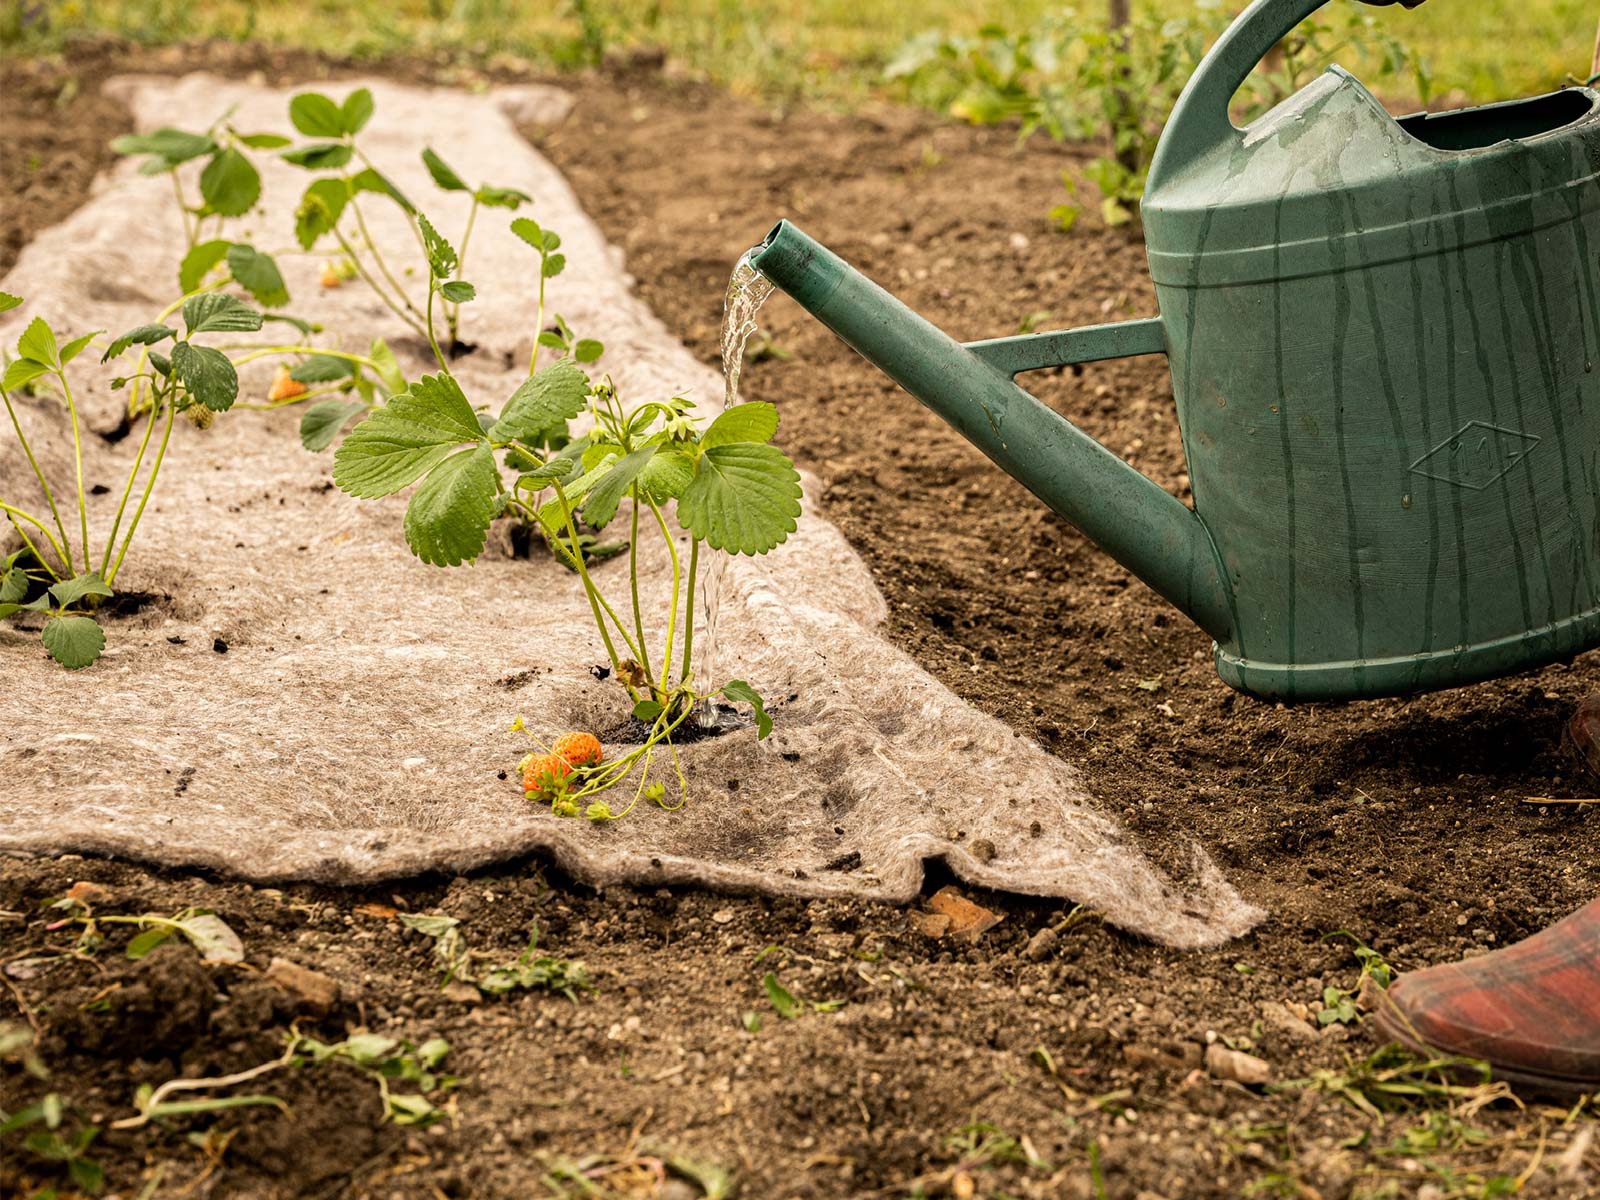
left=750, top=0, right=1600, bottom=701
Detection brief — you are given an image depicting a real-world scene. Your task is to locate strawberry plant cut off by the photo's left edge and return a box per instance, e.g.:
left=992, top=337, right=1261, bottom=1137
left=0, top=293, right=272, bottom=667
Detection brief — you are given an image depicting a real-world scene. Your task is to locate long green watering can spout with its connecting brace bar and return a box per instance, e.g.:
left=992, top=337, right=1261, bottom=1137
left=750, top=221, right=1234, bottom=642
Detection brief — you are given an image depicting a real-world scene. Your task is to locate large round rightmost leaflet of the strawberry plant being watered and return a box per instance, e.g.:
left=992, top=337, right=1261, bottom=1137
left=678, top=442, right=800, bottom=554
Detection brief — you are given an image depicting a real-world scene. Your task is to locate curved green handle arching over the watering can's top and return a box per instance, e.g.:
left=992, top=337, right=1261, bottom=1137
left=1150, top=0, right=1422, bottom=186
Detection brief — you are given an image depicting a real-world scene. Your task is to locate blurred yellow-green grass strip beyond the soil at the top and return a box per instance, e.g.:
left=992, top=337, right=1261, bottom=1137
left=0, top=0, right=1595, bottom=104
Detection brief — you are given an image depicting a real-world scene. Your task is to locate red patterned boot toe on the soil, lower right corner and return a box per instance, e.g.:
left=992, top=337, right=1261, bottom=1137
left=1376, top=899, right=1600, bottom=1098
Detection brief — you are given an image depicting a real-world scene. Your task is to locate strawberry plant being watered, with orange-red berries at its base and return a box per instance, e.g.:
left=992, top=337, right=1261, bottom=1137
left=333, top=218, right=800, bottom=821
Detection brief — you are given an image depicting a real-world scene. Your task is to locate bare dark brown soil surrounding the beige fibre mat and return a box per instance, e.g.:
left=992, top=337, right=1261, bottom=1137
left=0, top=46, right=1600, bottom=1200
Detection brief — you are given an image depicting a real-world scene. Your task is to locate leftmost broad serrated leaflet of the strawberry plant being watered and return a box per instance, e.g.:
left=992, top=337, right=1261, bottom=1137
left=333, top=374, right=483, bottom=498
